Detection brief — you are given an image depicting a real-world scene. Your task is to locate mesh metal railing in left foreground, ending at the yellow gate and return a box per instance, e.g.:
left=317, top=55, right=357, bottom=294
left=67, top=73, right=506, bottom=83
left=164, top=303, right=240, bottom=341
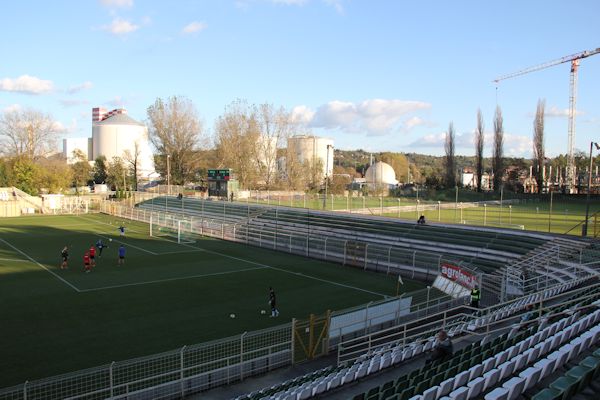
left=0, top=323, right=293, bottom=400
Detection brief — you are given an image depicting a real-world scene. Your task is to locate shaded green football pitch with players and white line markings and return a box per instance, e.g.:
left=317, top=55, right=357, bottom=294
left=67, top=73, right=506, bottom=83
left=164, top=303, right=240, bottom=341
left=0, top=214, right=425, bottom=388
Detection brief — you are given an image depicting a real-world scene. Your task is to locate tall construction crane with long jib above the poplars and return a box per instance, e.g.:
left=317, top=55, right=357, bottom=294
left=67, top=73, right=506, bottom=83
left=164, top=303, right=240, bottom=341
left=493, top=47, right=600, bottom=193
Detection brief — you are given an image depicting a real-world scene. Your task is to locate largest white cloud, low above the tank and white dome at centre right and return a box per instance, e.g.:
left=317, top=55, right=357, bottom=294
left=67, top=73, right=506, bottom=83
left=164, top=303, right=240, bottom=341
left=292, top=99, right=431, bottom=135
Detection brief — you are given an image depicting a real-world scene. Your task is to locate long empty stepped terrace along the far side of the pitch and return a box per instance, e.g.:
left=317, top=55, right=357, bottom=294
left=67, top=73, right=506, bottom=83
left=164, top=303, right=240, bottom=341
left=139, top=197, right=549, bottom=272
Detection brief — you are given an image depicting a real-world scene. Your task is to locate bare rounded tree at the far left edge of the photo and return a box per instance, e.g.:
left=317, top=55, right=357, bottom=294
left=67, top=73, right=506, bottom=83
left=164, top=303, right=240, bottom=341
left=0, top=109, right=59, bottom=160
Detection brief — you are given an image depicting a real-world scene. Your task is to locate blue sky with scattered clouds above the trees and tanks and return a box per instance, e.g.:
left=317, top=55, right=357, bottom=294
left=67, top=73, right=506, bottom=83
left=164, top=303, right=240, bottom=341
left=0, top=0, right=600, bottom=157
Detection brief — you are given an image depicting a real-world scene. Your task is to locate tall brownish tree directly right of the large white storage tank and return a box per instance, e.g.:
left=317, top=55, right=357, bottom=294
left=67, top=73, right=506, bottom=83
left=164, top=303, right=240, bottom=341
left=147, top=96, right=203, bottom=185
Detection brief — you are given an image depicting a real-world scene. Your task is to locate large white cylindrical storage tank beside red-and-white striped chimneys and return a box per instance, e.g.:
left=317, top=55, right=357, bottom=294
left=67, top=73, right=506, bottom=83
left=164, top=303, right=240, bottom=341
left=92, top=110, right=154, bottom=177
